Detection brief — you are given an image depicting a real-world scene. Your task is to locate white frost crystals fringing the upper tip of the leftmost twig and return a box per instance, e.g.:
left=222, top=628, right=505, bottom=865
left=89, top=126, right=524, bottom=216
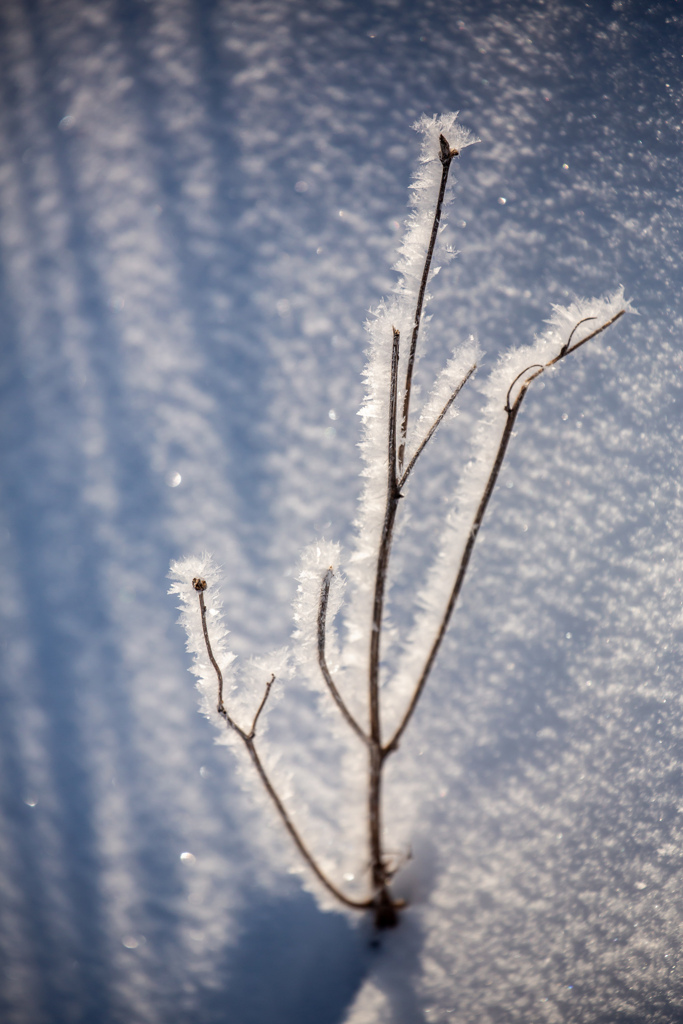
left=168, top=552, right=236, bottom=729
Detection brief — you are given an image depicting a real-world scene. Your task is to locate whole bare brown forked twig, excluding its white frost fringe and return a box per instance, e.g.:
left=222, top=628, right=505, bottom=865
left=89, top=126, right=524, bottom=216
left=174, top=120, right=626, bottom=928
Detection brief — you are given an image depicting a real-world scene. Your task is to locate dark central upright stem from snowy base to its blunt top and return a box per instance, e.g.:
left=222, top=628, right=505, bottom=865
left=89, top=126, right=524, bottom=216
left=368, top=328, right=401, bottom=928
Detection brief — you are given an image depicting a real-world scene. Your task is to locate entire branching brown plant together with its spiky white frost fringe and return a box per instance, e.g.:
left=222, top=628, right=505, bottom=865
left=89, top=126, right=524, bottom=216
left=170, top=114, right=629, bottom=928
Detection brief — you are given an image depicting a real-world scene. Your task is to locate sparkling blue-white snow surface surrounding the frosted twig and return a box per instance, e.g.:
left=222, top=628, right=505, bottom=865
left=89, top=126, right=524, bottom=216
left=0, top=0, right=683, bottom=1024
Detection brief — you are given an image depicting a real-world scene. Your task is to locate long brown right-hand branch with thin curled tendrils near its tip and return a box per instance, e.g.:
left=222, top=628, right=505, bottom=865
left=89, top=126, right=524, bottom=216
left=383, top=309, right=626, bottom=757
